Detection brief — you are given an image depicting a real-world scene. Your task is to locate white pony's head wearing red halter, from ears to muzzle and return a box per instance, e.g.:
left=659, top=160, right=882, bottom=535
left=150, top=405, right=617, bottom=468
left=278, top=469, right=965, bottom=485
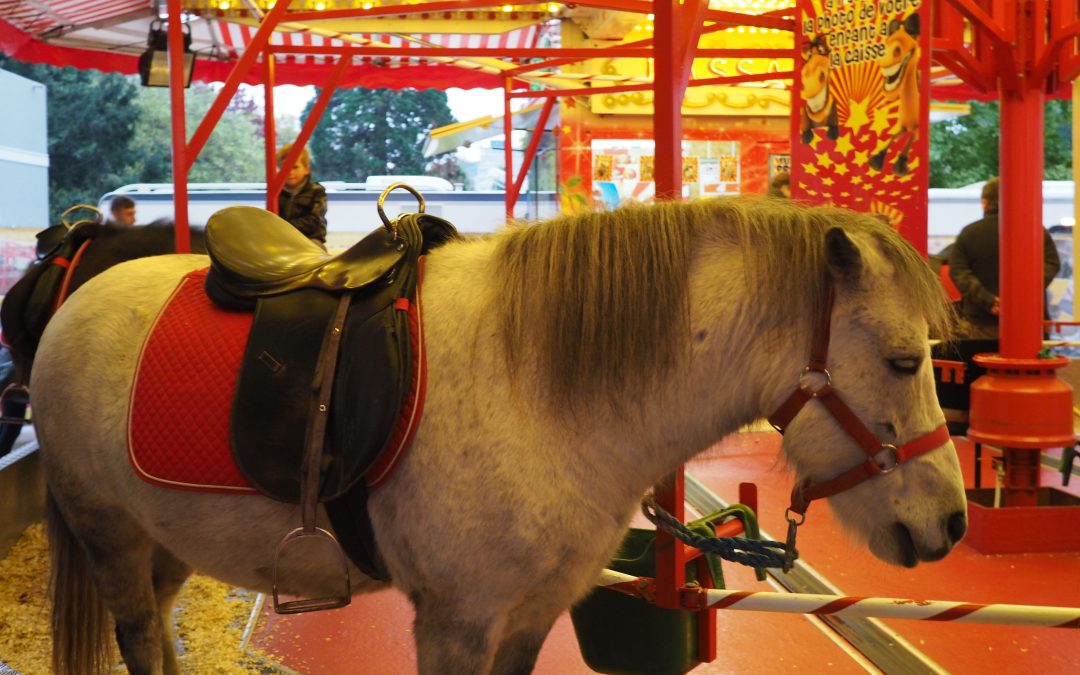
left=764, top=212, right=967, bottom=567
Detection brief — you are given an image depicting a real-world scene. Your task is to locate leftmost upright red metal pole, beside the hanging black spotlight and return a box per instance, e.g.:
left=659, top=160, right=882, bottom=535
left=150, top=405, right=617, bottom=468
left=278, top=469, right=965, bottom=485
left=167, top=0, right=191, bottom=253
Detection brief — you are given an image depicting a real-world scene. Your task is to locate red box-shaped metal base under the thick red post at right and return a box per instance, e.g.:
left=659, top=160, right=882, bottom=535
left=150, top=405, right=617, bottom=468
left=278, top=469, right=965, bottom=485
left=963, top=487, right=1080, bottom=553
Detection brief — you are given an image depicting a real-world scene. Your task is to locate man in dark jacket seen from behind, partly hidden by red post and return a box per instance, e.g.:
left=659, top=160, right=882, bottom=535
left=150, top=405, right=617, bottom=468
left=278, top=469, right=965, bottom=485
left=948, top=178, right=1061, bottom=338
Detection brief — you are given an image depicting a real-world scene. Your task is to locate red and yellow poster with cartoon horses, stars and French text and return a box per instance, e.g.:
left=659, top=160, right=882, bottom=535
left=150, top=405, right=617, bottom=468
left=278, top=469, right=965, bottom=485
left=791, top=0, right=930, bottom=254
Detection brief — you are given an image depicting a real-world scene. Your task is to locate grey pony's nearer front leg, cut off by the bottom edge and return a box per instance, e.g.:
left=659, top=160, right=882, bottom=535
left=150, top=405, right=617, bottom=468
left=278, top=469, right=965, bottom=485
left=413, top=589, right=499, bottom=675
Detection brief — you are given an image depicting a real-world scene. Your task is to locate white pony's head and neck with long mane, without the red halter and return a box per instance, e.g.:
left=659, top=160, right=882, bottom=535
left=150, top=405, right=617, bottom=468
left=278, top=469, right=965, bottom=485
left=491, top=198, right=967, bottom=565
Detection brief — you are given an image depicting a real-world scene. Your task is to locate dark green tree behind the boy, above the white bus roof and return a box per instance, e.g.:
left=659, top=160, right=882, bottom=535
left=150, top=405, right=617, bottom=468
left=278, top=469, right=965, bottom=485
left=303, top=89, right=455, bottom=181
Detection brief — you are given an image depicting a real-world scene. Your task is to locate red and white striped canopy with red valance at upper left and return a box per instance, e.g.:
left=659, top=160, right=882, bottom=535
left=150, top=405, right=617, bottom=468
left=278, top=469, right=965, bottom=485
left=0, top=0, right=557, bottom=89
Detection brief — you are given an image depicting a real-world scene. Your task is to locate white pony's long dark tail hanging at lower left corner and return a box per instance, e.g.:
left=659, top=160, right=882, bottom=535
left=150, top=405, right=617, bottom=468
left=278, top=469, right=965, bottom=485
left=45, top=492, right=113, bottom=675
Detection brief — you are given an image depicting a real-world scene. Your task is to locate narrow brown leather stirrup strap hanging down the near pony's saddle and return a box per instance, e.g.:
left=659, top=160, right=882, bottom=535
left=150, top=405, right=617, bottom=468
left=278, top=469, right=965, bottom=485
left=300, top=293, right=352, bottom=535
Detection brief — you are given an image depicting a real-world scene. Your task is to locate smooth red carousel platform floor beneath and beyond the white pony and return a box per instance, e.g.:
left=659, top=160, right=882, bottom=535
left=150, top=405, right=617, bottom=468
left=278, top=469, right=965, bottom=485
left=252, top=432, right=1080, bottom=675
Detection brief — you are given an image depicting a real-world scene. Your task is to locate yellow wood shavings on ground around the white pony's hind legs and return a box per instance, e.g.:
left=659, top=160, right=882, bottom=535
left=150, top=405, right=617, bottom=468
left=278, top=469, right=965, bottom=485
left=0, top=524, right=274, bottom=675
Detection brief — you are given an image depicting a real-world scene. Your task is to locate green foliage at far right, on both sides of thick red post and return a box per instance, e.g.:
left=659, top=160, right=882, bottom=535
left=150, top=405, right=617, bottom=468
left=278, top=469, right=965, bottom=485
left=930, top=99, right=1072, bottom=188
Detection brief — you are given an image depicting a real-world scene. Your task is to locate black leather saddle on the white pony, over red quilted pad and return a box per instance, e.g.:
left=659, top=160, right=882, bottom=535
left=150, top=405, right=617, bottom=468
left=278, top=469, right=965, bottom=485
left=206, top=200, right=458, bottom=571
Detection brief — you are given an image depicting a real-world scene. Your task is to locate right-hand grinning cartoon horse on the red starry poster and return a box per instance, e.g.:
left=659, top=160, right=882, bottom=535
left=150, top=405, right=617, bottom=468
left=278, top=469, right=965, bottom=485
left=869, top=14, right=921, bottom=176
